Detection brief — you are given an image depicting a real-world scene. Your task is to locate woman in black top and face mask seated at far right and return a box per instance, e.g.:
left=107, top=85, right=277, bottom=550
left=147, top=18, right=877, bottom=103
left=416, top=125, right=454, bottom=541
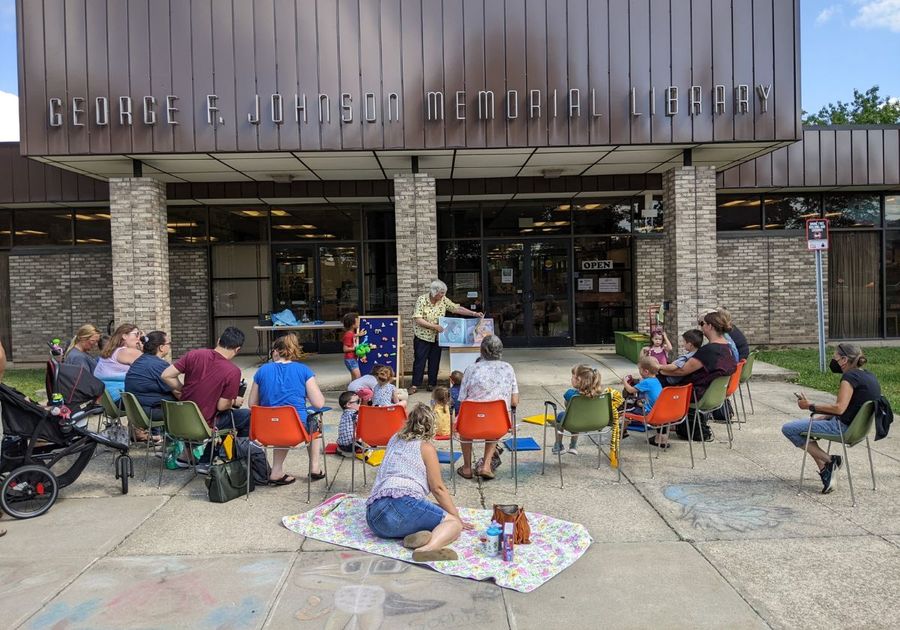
left=781, top=343, right=881, bottom=494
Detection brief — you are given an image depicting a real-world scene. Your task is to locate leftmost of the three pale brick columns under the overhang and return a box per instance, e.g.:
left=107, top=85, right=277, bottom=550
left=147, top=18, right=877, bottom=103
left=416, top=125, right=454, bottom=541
left=109, top=177, right=172, bottom=332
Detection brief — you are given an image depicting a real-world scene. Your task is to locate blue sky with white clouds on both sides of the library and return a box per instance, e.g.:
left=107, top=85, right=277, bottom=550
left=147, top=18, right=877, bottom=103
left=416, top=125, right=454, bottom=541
left=0, top=0, right=900, bottom=141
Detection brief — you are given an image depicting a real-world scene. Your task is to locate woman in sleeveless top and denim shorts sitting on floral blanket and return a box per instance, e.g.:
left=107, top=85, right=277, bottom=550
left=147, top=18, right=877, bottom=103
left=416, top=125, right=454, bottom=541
left=366, top=403, right=472, bottom=562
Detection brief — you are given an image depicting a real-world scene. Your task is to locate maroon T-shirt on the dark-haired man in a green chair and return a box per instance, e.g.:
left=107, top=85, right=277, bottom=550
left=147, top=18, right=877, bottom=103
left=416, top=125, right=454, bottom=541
left=173, top=348, right=241, bottom=427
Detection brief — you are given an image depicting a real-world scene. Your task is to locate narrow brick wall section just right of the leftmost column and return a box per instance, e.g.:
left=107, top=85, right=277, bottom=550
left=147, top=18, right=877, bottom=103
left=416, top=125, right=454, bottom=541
left=169, top=247, right=210, bottom=358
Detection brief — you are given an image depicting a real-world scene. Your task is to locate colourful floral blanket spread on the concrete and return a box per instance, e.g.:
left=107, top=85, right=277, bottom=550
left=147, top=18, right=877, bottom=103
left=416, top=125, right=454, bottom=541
left=282, top=494, right=593, bottom=593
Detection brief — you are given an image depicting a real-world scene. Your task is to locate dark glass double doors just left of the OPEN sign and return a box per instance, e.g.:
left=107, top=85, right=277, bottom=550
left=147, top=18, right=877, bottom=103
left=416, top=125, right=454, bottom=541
left=484, top=240, right=572, bottom=346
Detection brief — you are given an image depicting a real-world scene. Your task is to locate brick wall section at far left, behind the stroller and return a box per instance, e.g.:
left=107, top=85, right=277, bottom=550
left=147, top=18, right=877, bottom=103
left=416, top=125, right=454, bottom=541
left=9, top=249, right=113, bottom=362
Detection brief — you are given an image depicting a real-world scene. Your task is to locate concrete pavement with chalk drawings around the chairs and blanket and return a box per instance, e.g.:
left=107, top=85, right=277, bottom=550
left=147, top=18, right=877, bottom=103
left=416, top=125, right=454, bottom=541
left=0, top=349, right=900, bottom=628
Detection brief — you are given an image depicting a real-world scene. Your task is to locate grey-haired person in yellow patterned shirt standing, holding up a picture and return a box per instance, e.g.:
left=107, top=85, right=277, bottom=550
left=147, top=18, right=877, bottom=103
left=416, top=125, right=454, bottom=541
left=409, top=280, right=481, bottom=394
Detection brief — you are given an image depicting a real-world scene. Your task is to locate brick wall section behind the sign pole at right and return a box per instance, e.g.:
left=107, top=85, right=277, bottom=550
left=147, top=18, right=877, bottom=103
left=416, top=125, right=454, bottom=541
left=716, top=235, right=828, bottom=344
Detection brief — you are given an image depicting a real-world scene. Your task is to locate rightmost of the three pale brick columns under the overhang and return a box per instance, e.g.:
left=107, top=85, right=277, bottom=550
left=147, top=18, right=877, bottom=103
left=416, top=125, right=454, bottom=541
left=663, top=166, right=717, bottom=348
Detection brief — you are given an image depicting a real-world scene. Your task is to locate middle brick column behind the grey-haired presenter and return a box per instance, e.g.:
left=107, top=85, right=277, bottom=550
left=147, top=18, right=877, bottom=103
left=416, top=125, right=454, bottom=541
left=394, top=173, right=438, bottom=372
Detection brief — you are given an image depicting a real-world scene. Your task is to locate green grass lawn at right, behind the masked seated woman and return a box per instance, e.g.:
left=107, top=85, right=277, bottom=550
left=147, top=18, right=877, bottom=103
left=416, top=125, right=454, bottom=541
left=759, top=346, right=900, bottom=405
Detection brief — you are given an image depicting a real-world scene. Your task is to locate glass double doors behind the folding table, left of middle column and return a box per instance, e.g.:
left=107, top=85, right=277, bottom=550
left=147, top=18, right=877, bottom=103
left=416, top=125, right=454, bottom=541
left=272, top=245, right=360, bottom=352
